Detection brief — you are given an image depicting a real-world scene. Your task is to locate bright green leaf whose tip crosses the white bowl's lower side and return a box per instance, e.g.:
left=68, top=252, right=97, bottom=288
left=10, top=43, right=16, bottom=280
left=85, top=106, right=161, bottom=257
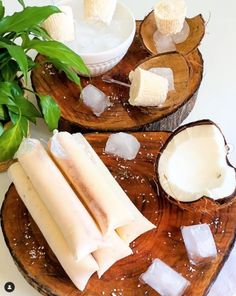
left=28, top=39, right=89, bottom=75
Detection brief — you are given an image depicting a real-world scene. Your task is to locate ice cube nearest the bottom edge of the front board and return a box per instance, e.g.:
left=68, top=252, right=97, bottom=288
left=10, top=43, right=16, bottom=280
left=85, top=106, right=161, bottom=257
left=140, top=259, right=190, bottom=296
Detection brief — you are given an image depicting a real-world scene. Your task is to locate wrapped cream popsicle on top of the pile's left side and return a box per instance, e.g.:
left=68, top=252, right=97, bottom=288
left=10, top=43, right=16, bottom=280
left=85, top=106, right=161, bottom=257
left=17, top=139, right=102, bottom=260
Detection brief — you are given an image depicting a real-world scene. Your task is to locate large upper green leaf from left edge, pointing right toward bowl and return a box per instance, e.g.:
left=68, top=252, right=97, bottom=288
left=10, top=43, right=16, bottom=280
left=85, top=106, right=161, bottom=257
left=0, top=5, right=60, bottom=34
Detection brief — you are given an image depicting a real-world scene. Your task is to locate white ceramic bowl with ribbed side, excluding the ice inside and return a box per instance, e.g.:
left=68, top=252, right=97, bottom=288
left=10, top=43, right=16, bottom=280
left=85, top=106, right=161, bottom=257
left=61, top=0, right=136, bottom=77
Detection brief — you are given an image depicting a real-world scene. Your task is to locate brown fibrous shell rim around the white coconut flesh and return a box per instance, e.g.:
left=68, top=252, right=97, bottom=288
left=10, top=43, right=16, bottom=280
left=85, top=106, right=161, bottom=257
left=155, top=119, right=236, bottom=214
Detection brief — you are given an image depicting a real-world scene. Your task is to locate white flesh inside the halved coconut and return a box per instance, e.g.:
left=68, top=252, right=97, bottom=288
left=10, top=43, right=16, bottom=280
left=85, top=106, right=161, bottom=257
left=158, top=124, right=236, bottom=202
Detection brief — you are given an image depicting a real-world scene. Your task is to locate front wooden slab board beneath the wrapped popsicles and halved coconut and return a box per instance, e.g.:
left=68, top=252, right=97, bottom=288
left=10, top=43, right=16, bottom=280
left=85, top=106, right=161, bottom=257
left=1, top=132, right=236, bottom=296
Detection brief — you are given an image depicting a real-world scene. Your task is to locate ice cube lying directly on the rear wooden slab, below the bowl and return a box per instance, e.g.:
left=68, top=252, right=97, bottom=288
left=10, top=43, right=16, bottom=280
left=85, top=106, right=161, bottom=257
left=81, top=84, right=112, bottom=117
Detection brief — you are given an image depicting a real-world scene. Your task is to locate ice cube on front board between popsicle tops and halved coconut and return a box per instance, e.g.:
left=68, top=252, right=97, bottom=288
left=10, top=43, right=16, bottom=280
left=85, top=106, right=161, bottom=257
left=105, top=133, right=140, bottom=160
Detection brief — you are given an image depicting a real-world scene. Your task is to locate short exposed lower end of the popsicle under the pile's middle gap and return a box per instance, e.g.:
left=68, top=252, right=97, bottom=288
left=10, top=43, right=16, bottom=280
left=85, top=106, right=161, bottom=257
left=92, top=231, right=133, bottom=278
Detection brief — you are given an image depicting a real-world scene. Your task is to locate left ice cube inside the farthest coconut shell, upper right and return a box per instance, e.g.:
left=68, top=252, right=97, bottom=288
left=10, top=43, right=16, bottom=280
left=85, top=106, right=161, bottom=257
left=153, top=31, right=176, bottom=53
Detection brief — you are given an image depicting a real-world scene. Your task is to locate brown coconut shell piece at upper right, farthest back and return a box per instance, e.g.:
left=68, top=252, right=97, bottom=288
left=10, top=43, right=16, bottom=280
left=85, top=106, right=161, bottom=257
left=139, top=11, right=205, bottom=55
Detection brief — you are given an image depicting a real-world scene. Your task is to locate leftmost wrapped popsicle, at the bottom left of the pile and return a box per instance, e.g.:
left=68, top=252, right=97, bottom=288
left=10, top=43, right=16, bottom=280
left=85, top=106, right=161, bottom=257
left=8, top=163, right=98, bottom=291
